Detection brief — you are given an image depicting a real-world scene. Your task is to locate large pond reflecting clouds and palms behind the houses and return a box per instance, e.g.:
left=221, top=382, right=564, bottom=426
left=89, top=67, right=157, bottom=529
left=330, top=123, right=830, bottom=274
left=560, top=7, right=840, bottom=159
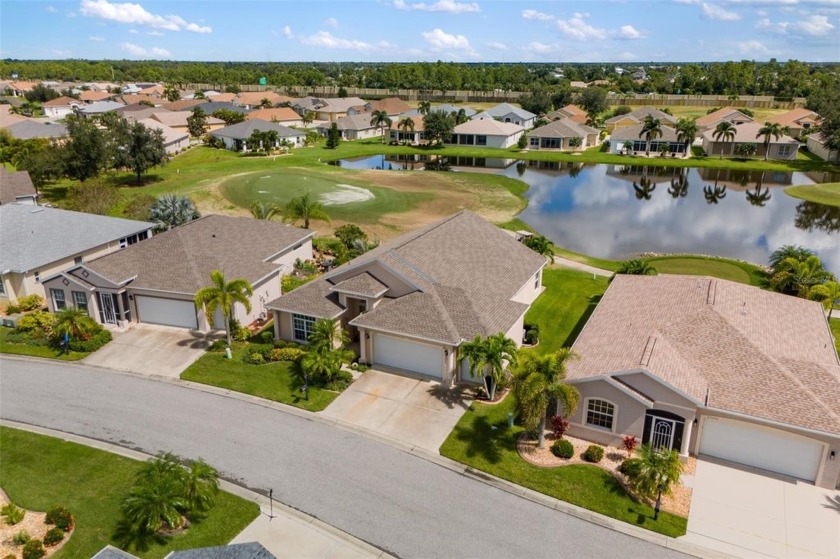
left=332, top=155, right=840, bottom=272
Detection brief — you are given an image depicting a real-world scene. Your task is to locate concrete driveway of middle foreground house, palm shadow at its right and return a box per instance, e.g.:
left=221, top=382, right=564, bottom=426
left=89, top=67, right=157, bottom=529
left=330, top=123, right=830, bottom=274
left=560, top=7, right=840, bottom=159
left=320, top=370, right=472, bottom=453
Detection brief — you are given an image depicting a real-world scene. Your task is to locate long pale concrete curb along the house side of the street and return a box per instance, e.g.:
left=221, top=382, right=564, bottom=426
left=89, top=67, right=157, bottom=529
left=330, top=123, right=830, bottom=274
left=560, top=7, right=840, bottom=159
left=0, top=354, right=734, bottom=559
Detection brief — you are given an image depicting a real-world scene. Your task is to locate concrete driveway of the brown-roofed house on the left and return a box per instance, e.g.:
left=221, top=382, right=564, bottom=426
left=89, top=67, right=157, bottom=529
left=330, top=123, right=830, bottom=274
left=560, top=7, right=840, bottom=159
left=83, top=324, right=217, bottom=378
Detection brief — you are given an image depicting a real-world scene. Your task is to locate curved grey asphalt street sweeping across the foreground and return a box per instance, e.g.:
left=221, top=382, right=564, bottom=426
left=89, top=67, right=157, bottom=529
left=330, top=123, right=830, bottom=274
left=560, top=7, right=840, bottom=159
left=0, top=360, right=685, bottom=559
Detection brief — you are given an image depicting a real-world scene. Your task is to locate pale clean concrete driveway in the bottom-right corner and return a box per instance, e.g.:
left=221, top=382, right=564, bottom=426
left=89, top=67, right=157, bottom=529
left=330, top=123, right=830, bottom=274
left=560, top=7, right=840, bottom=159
left=683, top=459, right=840, bottom=559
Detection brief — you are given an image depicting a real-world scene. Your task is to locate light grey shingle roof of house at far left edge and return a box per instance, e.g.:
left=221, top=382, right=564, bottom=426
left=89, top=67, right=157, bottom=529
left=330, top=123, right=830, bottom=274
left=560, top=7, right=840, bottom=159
left=0, top=204, right=152, bottom=272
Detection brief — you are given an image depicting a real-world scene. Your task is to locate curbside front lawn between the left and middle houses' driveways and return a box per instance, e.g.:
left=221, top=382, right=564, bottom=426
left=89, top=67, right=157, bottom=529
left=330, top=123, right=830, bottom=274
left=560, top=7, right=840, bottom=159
left=181, top=343, right=338, bottom=411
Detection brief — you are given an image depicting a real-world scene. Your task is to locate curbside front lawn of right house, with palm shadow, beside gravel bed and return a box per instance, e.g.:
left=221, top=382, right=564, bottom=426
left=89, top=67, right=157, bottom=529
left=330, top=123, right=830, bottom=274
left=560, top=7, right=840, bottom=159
left=440, top=397, right=687, bottom=537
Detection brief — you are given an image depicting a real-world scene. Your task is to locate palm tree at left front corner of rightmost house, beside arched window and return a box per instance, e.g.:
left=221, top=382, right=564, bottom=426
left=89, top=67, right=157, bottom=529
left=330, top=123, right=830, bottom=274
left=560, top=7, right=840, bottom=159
left=513, top=348, right=580, bottom=448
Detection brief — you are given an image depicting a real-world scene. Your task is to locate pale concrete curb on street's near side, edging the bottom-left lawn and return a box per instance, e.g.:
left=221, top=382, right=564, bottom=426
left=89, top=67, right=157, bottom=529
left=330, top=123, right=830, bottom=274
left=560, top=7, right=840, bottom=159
left=0, top=419, right=396, bottom=559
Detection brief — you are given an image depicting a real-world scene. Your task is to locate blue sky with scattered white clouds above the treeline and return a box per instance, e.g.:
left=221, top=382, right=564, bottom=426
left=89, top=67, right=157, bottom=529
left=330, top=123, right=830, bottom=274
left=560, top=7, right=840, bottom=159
left=0, top=0, right=840, bottom=63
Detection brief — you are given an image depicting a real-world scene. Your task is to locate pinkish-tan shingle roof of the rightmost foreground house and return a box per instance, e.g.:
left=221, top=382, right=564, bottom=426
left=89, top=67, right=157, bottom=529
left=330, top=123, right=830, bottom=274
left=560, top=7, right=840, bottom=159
left=568, top=275, right=840, bottom=434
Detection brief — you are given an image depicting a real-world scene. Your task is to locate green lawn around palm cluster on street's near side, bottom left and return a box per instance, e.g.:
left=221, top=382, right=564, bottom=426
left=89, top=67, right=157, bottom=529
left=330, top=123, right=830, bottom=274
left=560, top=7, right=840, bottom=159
left=0, top=427, right=259, bottom=559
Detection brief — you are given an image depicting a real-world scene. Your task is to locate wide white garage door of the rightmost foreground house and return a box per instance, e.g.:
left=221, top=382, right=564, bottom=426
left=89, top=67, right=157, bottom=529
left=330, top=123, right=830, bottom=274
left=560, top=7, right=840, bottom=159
left=700, top=417, right=823, bottom=481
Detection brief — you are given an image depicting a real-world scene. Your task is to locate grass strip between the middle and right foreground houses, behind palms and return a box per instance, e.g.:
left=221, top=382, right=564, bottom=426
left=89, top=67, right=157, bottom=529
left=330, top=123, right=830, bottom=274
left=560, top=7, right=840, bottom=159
left=525, top=268, right=607, bottom=353
